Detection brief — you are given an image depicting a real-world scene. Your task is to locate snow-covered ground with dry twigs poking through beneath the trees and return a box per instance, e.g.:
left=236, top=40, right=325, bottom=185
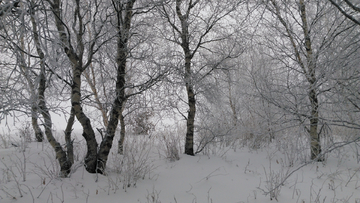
left=0, top=130, right=360, bottom=203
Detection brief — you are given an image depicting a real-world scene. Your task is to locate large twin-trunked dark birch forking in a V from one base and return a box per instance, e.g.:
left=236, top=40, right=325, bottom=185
left=47, top=0, right=162, bottom=174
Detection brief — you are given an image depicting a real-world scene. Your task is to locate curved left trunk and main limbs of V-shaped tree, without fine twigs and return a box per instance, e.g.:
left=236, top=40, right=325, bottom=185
left=48, top=0, right=98, bottom=173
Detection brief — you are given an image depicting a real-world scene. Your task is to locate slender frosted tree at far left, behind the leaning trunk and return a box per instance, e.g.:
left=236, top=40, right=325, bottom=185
left=0, top=1, right=43, bottom=142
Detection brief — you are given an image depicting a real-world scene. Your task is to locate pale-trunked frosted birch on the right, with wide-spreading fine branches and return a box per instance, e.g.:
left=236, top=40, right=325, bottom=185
left=258, top=0, right=358, bottom=161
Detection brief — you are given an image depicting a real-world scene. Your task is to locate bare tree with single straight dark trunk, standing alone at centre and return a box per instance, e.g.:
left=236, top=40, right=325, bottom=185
left=160, top=0, right=239, bottom=155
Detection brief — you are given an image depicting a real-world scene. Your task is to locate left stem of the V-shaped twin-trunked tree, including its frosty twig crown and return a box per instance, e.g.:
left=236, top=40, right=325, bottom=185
left=47, top=0, right=112, bottom=173
